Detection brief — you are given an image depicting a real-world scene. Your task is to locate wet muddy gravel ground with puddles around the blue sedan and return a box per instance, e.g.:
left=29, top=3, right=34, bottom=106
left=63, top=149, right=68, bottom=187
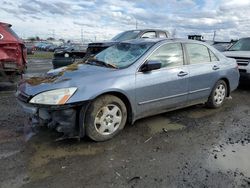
left=0, top=60, right=250, bottom=188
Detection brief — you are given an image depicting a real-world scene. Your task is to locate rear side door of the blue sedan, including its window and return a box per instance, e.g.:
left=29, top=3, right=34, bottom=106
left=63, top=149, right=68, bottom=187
left=185, top=43, right=220, bottom=102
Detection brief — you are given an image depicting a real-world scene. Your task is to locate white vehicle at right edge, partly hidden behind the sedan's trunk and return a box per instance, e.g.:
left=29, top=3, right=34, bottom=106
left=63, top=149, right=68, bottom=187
left=224, top=37, right=250, bottom=79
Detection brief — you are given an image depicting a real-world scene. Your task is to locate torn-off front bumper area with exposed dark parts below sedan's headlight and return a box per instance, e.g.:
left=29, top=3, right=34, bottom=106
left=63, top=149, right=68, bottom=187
left=17, top=93, right=90, bottom=138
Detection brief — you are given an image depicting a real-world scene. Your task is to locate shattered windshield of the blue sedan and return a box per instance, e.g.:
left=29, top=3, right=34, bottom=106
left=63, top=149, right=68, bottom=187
left=93, top=43, right=154, bottom=69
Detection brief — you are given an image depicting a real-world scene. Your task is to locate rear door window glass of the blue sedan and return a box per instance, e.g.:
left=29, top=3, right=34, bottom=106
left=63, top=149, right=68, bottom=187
left=186, top=44, right=210, bottom=64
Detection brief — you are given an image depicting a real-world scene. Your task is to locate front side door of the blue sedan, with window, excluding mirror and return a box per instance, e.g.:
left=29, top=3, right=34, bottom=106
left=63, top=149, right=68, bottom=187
left=136, top=43, right=188, bottom=117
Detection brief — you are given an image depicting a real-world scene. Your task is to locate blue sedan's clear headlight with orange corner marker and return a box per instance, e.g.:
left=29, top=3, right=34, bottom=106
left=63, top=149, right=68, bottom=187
left=30, top=87, right=77, bottom=105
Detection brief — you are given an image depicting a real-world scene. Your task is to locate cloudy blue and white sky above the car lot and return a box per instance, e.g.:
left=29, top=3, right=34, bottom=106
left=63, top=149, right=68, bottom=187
left=0, top=0, right=250, bottom=41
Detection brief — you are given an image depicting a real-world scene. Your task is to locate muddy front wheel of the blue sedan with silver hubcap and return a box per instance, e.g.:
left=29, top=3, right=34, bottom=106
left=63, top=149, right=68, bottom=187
left=85, top=95, right=127, bottom=141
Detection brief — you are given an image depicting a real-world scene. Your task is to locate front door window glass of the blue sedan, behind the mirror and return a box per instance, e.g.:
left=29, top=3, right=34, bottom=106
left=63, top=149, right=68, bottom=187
left=148, top=43, right=183, bottom=68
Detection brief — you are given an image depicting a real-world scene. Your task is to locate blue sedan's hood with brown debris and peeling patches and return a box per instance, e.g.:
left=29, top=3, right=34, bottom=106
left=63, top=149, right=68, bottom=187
left=19, top=64, right=118, bottom=96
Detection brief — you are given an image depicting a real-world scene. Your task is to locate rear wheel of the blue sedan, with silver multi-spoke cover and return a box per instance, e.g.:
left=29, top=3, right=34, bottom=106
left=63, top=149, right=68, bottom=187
left=206, top=80, right=228, bottom=108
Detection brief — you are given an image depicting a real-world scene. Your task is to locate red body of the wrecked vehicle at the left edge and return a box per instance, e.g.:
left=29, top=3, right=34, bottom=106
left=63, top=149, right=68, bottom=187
left=0, top=22, right=27, bottom=74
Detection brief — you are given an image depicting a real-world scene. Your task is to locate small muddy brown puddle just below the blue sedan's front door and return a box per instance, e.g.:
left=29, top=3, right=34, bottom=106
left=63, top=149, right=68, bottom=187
left=138, top=116, right=185, bottom=134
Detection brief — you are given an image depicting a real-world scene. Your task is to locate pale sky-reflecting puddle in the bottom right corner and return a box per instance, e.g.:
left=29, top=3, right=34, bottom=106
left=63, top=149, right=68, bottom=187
left=209, top=144, right=250, bottom=177
